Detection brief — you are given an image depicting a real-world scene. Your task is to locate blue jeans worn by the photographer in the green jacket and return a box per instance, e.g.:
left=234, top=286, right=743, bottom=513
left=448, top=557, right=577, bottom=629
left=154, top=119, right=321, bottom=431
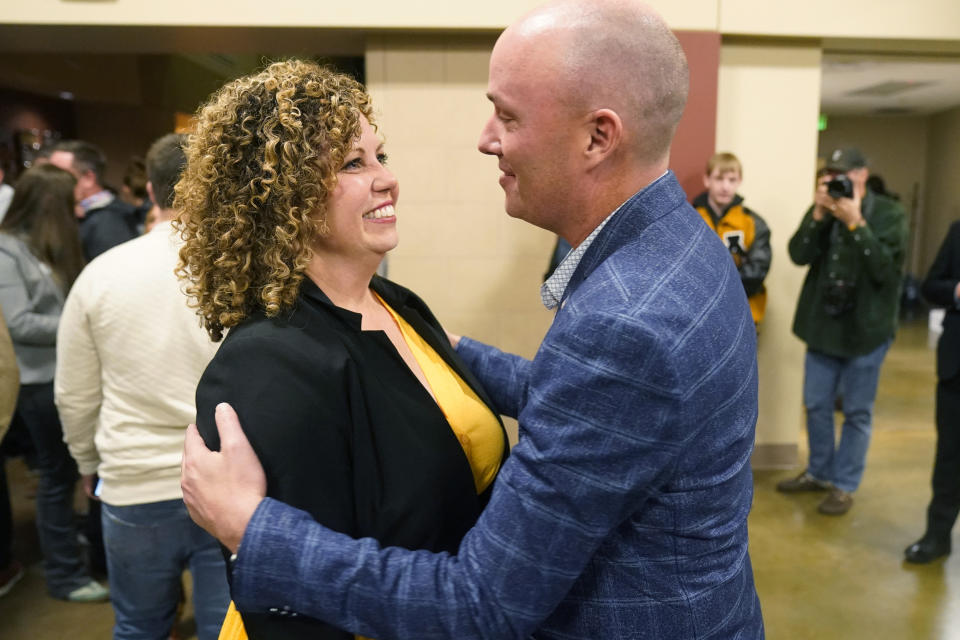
left=803, top=339, right=893, bottom=491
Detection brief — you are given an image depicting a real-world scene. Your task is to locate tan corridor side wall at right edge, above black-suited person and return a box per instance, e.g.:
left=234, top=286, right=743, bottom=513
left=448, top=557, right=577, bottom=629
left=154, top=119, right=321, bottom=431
left=920, top=108, right=960, bottom=275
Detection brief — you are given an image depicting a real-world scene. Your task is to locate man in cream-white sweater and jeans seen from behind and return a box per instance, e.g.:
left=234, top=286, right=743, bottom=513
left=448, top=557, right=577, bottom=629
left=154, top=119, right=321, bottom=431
left=55, top=134, right=229, bottom=640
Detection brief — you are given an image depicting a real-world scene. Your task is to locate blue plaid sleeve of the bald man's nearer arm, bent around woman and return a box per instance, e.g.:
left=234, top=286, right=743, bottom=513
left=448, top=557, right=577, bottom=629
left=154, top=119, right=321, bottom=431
left=227, top=314, right=696, bottom=640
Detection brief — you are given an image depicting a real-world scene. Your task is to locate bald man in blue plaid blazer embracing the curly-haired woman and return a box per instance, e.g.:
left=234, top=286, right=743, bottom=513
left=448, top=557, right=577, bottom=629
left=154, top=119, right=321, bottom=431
left=182, top=0, right=763, bottom=640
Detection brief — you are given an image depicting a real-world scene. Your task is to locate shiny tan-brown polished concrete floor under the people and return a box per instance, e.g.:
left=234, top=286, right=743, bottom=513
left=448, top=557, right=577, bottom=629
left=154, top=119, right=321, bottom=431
left=0, top=324, right=960, bottom=640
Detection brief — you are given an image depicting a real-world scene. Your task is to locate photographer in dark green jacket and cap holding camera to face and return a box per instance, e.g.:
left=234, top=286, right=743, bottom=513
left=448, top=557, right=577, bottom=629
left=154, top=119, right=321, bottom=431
left=777, top=148, right=907, bottom=515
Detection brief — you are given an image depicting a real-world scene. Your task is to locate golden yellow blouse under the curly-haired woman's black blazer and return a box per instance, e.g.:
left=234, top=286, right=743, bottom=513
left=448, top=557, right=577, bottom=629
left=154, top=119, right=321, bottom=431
left=219, top=294, right=505, bottom=640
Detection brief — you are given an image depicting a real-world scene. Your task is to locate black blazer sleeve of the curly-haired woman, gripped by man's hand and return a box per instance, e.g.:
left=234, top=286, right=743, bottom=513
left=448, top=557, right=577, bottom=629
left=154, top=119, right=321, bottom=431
left=197, top=335, right=355, bottom=533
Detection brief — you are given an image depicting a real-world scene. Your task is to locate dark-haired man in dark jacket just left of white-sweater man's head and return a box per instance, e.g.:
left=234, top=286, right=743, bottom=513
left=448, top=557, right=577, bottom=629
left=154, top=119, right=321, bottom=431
left=50, top=140, right=137, bottom=262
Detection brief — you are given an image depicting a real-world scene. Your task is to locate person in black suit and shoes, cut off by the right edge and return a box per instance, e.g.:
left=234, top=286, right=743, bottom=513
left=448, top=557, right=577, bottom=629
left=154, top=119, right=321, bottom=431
left=904, top=222, right=960, bottom=564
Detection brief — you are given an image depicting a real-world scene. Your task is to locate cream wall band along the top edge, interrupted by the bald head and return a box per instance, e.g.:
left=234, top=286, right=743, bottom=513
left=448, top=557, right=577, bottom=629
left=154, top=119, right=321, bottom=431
left=7, top=0, right=960, bottom=39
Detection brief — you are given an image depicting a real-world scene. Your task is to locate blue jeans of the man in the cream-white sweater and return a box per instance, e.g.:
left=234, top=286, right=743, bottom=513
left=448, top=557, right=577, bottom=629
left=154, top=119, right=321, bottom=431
left=102, top=500, right=230, bottom=640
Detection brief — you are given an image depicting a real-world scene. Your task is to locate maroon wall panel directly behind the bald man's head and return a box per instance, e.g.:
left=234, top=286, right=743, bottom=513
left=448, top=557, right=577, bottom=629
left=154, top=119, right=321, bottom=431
left=670, top=31, right=720, bottom=199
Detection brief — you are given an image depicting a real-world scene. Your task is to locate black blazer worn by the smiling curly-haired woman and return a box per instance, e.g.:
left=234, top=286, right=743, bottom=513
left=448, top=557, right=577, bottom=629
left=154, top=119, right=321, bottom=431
left=197, top=276, right=508, bottom=640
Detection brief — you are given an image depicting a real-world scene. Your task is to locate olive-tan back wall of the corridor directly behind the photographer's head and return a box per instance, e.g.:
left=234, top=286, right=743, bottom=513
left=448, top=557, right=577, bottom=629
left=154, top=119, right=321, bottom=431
left=819, top=116, right=933, bottom=274
